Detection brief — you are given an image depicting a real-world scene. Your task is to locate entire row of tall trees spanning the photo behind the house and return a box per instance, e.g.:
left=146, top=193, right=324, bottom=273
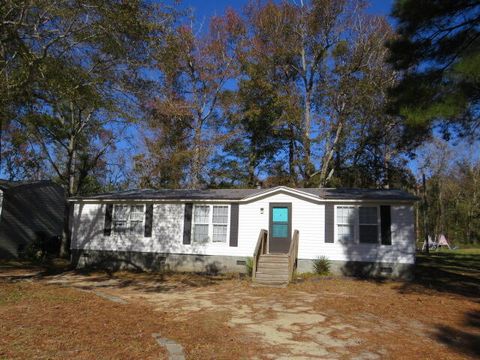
left=0, top=0, right=480, bottom=245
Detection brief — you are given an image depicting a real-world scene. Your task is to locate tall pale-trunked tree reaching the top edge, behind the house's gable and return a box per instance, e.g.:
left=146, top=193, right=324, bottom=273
left=247, top=0, right=359, bottom=185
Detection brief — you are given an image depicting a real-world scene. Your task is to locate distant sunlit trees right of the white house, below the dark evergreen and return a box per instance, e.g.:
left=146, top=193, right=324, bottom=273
left=418, top=139, right=480, bottom=244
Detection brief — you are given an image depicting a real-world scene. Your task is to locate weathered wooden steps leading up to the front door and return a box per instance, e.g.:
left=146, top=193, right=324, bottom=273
left=253, top=254, right=289, bottom=286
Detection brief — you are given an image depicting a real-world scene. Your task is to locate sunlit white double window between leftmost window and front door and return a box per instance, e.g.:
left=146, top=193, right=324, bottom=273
left=193, top=205, right=229, bottom=242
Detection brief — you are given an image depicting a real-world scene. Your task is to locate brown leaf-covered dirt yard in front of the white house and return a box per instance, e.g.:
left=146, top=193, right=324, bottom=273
left=0, top=255, right=480, bottom=359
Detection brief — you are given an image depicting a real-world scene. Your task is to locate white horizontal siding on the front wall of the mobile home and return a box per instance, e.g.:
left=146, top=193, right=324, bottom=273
left=72, top=193, right=415, bottom=263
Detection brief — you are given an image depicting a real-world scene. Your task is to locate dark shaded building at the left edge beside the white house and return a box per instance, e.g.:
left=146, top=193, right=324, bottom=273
left=0, top=180, right=66, bottom=258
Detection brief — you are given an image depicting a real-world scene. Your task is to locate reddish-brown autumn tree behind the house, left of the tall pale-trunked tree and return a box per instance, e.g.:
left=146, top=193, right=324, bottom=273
left=144, top=11, right=244, bottom=188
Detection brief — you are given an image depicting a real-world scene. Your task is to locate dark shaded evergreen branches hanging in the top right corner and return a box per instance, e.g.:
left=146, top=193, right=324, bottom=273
left=389, top=0, right=480, bottom=142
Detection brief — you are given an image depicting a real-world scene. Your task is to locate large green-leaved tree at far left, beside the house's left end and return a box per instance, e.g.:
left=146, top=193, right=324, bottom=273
left=0, top=0, right=176, bottom=254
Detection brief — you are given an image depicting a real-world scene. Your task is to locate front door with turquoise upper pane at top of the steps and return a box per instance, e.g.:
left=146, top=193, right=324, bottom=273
left=268, top=203, right=292, bottom=254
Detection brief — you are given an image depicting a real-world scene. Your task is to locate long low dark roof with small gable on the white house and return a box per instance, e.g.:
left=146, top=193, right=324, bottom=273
left=70, top=186, right=418, bottom=201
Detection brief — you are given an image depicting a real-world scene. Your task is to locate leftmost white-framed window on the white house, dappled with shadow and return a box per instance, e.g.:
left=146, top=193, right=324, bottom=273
left=113, top=205, right=145, bottom=235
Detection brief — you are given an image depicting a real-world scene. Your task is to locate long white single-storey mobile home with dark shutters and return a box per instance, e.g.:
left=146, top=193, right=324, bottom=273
left=70, top=186, right=416, bottom=284
